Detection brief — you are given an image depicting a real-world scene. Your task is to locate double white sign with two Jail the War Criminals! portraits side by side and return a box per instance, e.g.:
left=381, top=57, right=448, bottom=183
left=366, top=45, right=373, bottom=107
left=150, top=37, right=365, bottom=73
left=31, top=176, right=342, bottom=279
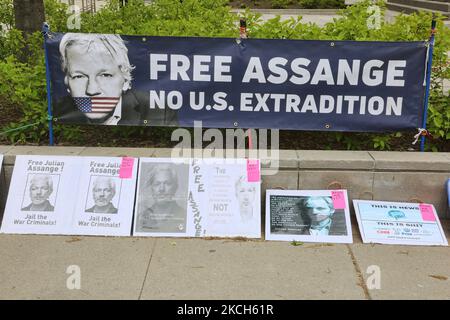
left=1, top=156, right=137, bottom=235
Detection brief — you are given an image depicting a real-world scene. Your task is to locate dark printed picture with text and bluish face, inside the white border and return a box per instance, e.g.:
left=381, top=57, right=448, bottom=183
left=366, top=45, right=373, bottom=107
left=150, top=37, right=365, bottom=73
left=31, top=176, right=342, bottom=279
left=270, top=196, right=347, bottom=236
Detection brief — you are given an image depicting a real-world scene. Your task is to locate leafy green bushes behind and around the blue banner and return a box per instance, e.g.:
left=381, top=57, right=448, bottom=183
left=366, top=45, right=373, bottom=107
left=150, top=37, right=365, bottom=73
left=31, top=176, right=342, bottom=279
left=0, top=0, right=450, bottom=150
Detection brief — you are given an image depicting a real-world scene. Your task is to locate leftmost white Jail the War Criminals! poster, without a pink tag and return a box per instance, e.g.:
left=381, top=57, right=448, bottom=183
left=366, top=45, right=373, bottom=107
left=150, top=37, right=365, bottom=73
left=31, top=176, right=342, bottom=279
left=0, top=155, right=80, bottom=234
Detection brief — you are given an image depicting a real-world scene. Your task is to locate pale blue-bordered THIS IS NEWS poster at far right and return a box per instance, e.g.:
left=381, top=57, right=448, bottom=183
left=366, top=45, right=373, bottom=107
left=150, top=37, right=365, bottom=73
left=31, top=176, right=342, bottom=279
left=353, top=200, right=448, bottom=246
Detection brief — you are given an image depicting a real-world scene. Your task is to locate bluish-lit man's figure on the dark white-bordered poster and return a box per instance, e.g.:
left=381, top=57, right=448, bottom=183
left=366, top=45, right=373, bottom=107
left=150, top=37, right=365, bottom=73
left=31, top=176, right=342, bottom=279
left=297, top=196, right=347, bottom=236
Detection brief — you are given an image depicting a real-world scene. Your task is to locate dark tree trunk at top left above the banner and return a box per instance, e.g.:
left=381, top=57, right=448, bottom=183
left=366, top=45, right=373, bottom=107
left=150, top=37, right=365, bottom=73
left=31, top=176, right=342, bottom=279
left=14, top=0, right=45, bottom=36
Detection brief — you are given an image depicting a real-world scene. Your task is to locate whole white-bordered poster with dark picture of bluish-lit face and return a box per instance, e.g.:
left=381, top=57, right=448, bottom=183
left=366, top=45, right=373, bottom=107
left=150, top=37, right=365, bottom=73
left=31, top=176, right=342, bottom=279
left=266, top=190, right=353, bottom=243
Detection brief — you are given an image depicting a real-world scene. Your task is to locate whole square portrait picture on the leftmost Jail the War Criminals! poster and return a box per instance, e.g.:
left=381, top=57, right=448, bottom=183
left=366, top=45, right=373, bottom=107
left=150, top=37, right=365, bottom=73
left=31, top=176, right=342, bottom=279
left=21, top=173, right=60, bottom=212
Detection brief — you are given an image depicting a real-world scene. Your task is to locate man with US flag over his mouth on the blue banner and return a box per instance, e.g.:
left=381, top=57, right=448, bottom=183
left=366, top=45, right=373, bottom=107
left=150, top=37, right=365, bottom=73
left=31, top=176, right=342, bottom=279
left=53, top=33, right=178, bottom=126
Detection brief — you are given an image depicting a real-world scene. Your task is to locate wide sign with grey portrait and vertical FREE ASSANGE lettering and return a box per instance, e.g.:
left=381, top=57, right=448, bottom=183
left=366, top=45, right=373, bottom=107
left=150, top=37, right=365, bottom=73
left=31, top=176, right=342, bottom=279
left=133, top=158, right=261, bottom=238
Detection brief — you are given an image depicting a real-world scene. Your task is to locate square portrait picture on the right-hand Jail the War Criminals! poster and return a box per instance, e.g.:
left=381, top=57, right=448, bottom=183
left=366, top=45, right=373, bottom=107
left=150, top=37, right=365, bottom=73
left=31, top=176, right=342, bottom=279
left=84, top=176, right=122, bottom=214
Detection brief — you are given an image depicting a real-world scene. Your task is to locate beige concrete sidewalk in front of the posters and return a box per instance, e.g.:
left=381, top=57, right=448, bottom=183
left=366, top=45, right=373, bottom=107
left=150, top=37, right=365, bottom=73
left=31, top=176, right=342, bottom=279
left=0, top=220, right=450, bottom=300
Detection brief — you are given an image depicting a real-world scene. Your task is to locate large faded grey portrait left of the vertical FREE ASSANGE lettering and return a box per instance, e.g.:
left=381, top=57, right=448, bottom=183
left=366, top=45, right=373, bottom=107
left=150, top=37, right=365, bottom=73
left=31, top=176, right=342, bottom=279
left=136, top=163, right=189, bottom=233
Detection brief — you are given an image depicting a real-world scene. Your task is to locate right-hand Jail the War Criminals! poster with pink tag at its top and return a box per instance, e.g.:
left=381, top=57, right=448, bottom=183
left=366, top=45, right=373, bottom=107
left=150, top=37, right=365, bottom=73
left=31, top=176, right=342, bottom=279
left=71, top=157, right=137, bottom=236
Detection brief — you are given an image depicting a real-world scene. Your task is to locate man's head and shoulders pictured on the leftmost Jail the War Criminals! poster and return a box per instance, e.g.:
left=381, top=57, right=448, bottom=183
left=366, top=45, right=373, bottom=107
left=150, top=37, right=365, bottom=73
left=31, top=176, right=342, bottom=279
left=21, top=174, right=55, bottom=212
